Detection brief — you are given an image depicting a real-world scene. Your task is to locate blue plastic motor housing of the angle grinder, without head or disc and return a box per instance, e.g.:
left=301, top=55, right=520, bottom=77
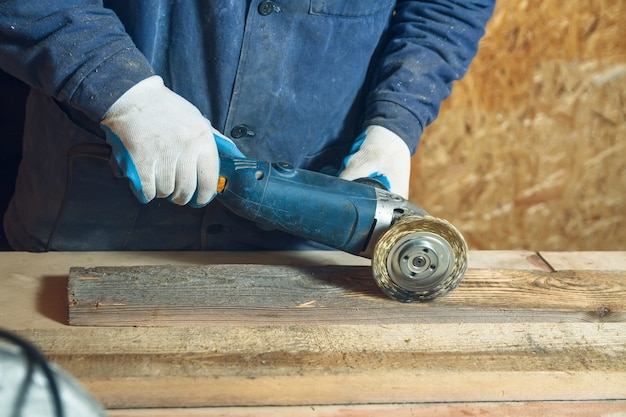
left=217, top=156, right=380, bottom=256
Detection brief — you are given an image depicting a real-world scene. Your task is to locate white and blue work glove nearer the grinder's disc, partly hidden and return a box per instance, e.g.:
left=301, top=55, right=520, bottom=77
left=339, top=126, right=411, bottom=198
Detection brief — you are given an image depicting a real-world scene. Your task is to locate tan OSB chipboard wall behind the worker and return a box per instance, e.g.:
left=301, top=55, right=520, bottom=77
left=410, top=0, right=626, bottom=250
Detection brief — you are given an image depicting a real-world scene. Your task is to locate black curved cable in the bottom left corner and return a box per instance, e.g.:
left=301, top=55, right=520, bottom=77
left=0, top=329, right=65, bottom=417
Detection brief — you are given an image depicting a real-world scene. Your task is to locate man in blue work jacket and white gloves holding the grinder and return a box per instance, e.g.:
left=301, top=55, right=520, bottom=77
left=0, top=0, right=494, bottom=251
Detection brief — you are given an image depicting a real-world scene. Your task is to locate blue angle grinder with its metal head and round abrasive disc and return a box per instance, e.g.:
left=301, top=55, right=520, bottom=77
left=217, top=155, right=467, bottom=302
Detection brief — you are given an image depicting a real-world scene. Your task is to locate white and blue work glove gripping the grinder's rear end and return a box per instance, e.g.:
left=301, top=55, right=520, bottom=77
left=101, top=75, right=243, bottom=207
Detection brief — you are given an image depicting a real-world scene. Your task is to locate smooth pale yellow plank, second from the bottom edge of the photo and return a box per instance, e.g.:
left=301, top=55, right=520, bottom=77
left=83, top=370, right=626, bottom=408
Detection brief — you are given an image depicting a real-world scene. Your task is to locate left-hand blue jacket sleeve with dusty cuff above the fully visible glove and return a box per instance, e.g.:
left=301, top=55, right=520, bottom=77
left=0, top=0, right=153, bottom=122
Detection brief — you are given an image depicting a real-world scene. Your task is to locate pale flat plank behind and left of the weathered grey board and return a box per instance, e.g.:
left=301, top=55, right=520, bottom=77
left=0, top=251, right=539, bottom=329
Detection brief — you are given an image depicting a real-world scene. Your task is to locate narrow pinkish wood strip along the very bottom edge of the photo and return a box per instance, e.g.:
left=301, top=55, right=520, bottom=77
left=108, top=401, right=626, bottom=417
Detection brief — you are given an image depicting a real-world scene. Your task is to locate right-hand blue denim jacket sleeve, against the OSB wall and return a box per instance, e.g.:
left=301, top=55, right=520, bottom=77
left=364, top=0, right=495, bottom=153
